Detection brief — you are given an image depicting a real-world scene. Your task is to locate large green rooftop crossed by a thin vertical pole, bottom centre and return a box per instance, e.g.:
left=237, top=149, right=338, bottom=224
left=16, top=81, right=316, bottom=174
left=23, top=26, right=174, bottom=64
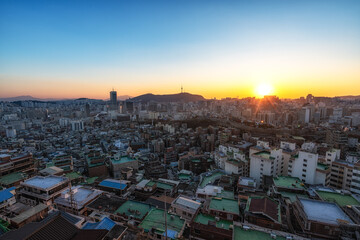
left=139, top=209, right=185, bottom=234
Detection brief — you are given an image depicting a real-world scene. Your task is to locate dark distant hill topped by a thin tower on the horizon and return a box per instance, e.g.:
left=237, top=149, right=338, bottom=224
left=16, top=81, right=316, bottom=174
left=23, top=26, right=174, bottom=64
left=129, top=93, right=206, bottom=102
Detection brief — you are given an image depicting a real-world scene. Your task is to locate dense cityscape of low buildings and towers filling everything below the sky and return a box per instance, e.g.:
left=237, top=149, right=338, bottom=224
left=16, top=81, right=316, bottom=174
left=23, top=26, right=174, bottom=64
left=0, top=90, right=360, bottom=239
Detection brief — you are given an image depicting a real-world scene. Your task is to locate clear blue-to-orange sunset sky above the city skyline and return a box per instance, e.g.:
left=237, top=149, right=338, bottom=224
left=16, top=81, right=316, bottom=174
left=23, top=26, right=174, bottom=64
left=0, top=0, right=360, bottom=99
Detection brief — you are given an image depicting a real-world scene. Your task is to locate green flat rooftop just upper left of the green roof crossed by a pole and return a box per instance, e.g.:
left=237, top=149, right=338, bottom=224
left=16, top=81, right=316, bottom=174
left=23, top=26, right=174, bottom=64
left=115, top=200, right=152, bottom=219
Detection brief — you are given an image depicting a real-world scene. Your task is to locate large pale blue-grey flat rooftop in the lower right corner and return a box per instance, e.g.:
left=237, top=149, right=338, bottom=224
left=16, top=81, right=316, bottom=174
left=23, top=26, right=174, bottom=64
left=299, top=198, right=353, bottom=225
